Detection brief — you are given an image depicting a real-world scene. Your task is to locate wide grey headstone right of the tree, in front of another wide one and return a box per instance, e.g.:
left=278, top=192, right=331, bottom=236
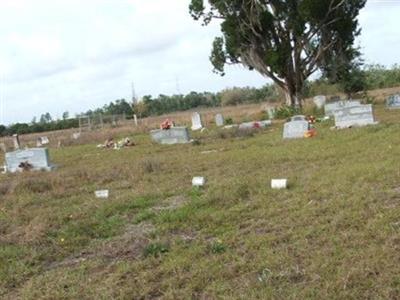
left=334, top=104, right=377, bottom=128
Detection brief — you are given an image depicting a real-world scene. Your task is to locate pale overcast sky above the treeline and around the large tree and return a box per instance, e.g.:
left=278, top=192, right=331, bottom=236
left=0, top=0, right=400, bottom=124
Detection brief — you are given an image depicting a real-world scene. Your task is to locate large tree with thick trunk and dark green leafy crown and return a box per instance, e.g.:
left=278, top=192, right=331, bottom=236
left=189, top=0, right=366, bottom=106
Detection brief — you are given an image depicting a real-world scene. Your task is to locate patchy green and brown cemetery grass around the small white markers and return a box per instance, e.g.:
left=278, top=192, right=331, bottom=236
left=0, top=105, right=400, bottom=299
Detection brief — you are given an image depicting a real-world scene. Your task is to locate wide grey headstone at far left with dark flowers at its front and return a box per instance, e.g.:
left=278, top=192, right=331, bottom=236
left=5, top=148, right=55, bottom=173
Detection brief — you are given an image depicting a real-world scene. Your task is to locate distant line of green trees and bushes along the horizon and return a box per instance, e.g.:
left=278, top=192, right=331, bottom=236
left=0, top=65, right=400, bottom=136
